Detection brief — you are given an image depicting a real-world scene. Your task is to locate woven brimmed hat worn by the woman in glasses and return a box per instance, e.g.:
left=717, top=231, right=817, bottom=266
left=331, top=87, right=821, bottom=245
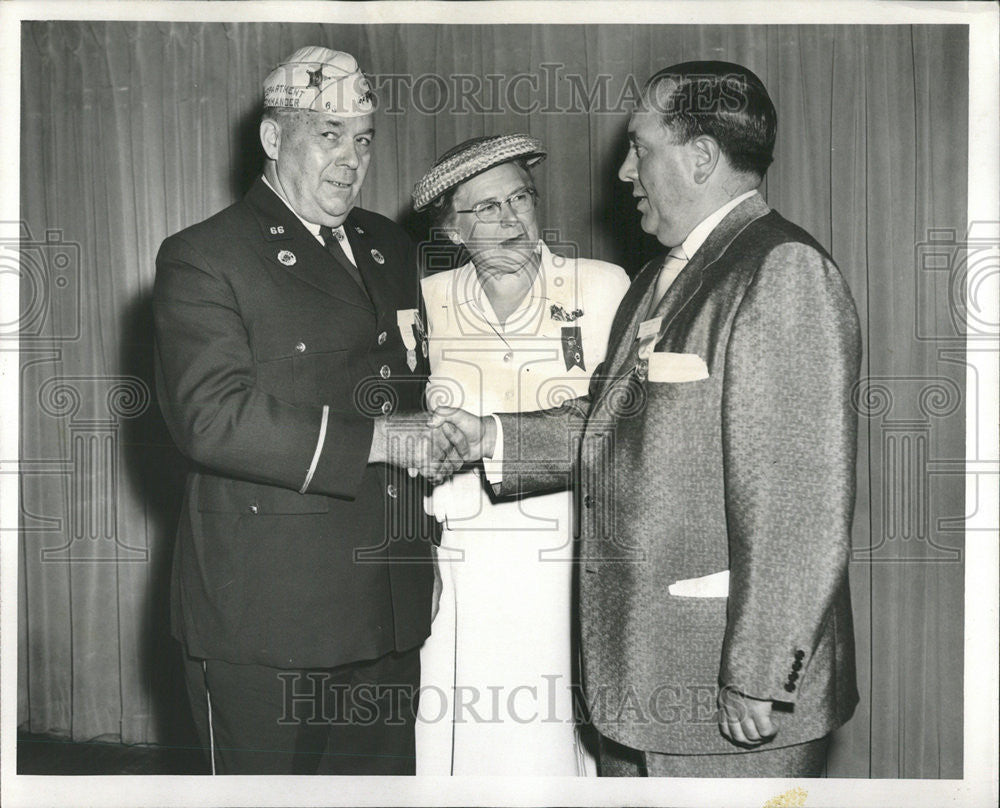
left=413, top=134, right=548, bottom=210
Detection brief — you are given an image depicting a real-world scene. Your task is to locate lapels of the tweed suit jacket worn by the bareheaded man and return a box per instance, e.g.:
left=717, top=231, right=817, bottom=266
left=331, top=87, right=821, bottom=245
left=595, top=194, right=770, bottom=410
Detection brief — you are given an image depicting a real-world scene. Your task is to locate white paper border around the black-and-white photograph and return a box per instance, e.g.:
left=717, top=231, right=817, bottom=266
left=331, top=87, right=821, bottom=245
left=0, top=0, right=1000, bottom=808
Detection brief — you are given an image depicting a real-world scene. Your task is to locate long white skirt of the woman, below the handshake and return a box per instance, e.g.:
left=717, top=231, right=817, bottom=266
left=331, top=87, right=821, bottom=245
left=416, top=472, right=596, bottom=776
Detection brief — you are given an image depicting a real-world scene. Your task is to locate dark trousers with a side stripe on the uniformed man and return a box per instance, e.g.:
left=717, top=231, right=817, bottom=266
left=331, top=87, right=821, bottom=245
left=185, top=648, right=420, bottom=774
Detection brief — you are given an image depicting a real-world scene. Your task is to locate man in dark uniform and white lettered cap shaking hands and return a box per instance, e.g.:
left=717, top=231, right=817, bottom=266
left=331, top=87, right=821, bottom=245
left=154, top=47, right=460, bottom=774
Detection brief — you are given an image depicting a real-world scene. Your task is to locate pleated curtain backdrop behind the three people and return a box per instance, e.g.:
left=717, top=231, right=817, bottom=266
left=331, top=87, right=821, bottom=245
left=18, top=22, right=968, bottom=778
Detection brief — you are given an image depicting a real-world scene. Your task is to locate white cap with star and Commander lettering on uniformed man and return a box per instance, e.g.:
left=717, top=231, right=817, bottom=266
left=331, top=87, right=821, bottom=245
left=264, top=45, right=375, bottom=118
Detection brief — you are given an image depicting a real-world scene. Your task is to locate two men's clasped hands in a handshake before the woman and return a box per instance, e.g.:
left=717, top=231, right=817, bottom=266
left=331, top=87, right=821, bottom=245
left=368, top=407, right=496, bottom=483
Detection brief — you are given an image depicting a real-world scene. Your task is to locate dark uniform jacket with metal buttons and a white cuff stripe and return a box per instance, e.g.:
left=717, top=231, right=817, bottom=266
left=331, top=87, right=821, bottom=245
left=154, top=179, right=436, bottom=668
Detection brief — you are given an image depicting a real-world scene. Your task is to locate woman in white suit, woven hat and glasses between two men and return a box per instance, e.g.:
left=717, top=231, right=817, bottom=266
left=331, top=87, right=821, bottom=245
left=413, top=134, right=629, bottom=775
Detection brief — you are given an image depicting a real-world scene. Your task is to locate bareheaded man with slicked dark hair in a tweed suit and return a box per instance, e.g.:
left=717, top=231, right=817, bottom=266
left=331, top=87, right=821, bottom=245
left=441, top=62, right=860, bottom=777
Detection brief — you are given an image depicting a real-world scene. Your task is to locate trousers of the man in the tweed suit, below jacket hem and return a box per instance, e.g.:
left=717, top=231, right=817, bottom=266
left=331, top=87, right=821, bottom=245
left=598, top=735, right=830, bottom=777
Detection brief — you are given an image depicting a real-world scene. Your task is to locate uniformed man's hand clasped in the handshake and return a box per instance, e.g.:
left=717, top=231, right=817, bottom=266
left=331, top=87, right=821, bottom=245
left=368, top=413, right=469, bottom=483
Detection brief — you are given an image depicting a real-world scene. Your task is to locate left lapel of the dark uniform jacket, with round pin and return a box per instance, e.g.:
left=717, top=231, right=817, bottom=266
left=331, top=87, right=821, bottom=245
left=246, top=179, right=372, bottom=311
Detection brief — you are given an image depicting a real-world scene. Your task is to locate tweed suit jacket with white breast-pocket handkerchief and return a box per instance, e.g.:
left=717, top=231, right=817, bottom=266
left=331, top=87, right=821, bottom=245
left=500, top=196, right=860, bottom=754
